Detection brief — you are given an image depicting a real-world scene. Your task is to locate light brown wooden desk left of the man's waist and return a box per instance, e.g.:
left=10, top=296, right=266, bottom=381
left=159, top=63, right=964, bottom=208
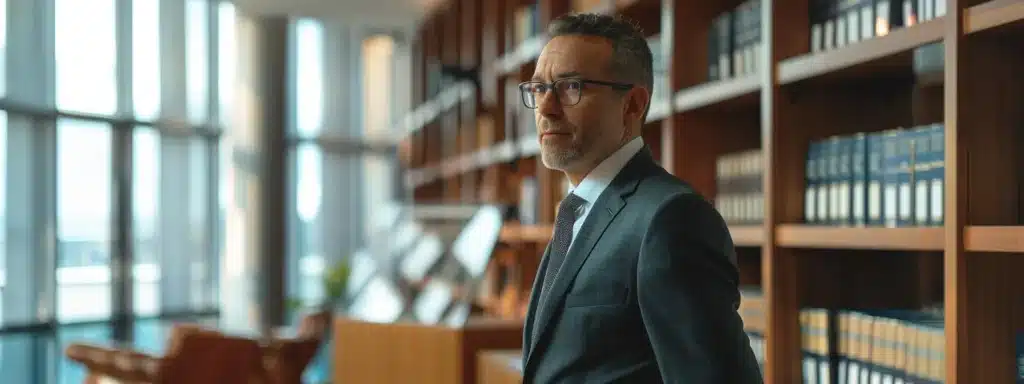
left=333, top=316, right=522, bottom=384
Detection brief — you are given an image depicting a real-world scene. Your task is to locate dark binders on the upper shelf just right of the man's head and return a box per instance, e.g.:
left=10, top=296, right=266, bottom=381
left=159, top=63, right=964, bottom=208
left=708, top=0, right=763, bottom=81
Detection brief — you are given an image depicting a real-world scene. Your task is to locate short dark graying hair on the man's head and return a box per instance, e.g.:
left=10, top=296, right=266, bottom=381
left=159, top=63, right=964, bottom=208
left=548, top=13, right=654, bottom=98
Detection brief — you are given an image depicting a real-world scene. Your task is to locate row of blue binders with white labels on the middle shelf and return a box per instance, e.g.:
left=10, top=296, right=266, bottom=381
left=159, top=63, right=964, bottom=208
left=804, top=123, right=945, bottom=227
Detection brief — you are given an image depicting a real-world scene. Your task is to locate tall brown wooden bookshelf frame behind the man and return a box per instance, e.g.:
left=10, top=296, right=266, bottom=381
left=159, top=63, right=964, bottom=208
left=402, top=0, right=1024, bottom=384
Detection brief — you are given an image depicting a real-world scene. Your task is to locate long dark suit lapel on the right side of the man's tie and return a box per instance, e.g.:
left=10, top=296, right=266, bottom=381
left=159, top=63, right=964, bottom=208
left=524, top=147, right=656, bottom=370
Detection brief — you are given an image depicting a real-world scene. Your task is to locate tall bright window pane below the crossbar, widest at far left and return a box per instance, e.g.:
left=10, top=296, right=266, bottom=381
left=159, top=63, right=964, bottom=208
left=56, top=120, right=113, bottom=322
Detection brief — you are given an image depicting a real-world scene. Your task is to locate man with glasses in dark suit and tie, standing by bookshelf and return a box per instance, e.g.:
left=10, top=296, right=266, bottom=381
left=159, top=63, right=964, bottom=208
left=519, top=14, right=762, bottom=384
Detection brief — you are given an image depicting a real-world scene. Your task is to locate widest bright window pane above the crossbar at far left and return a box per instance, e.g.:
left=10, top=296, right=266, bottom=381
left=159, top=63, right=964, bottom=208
left=53, top=0, right=118, bottom=115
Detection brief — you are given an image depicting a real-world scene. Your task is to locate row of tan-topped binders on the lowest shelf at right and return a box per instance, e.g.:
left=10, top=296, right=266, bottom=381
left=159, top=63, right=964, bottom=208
left=800, top=308, right=946, bottom=384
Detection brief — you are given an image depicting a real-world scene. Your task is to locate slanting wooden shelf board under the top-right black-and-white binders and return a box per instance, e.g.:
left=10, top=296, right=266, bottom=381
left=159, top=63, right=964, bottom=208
left=778, top=16, right=945, bottom=84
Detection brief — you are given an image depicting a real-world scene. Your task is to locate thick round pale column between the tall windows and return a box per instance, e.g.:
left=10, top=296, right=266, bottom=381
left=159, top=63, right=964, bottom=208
left=220, top=9, right=289, bottom=330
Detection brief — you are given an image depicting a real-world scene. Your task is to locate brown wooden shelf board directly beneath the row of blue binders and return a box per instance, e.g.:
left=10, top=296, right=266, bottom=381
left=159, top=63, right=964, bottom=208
left=776, top=224, right=945, bottom=251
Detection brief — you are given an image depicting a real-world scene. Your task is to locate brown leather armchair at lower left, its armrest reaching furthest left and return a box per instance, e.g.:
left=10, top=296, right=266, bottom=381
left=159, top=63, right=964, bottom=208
left=66, top=325, right=264, bottom=384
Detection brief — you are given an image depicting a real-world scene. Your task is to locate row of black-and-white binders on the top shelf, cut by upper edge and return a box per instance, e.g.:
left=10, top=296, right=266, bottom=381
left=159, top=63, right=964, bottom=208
left=809, top=0, right=946, bottom=52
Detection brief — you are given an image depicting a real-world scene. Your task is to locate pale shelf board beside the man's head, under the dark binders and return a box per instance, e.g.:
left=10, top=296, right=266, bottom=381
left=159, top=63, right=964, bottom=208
left=673, top=75, right=761, bottom=113
